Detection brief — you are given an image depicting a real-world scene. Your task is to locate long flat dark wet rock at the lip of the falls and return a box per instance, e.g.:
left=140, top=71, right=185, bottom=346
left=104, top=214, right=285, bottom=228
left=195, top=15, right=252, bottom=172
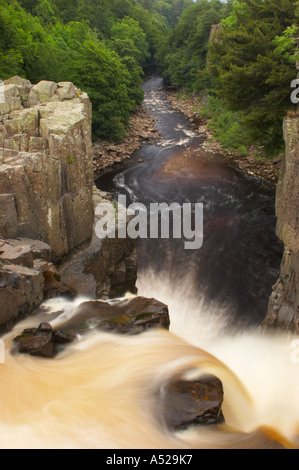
left=60, top=297, right=170, bottom=335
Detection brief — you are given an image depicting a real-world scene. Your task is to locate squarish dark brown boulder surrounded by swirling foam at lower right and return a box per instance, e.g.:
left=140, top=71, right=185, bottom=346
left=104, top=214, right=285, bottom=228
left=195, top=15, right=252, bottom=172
left=160, top=375, right=224, bottom=430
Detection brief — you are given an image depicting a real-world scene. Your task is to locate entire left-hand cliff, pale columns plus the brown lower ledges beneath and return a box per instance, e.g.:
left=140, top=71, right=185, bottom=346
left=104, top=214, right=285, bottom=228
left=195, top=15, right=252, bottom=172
left=0, top=77, right=136, bottom=332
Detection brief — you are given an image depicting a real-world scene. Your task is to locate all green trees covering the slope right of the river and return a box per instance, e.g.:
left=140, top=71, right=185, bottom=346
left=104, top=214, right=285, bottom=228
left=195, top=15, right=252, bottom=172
left=158, top=0, right=298, bottom=155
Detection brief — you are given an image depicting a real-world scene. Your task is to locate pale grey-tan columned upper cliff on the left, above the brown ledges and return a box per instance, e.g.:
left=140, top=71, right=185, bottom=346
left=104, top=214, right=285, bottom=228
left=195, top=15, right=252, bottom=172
left=0, top=77, right=93, bottom=259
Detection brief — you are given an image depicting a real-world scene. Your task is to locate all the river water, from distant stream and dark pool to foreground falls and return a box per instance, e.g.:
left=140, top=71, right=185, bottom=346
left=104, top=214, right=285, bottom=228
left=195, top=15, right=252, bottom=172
left=0, top=77, right=299, bottom=449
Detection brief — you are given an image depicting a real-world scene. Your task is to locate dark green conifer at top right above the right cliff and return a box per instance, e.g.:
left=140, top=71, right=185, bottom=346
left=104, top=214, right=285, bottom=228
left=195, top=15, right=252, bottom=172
left=208, top=0, right=295, bottom=154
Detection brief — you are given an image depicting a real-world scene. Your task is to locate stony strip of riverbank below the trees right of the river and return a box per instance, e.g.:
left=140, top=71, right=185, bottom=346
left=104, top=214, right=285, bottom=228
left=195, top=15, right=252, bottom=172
left=166, top=90, right=281, bottom=184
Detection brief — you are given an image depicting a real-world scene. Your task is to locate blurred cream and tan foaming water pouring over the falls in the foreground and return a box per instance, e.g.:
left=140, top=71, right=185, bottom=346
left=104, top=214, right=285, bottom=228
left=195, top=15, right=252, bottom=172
left=0, top=273, right=299, bottom=449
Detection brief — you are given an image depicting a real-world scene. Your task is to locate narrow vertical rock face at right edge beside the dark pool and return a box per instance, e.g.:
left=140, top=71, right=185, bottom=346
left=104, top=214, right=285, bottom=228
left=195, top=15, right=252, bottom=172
left=261, top=114, right=299, bottom=334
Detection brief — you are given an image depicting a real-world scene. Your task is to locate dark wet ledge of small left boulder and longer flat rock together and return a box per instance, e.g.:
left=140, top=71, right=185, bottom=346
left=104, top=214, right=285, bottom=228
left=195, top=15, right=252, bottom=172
left=13, top=297, right=170, bottom=358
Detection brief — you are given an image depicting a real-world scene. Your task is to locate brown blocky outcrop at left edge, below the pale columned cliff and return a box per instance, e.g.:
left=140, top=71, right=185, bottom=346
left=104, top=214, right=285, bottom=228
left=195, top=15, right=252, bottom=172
left=0, top=238, right=75, bottom=333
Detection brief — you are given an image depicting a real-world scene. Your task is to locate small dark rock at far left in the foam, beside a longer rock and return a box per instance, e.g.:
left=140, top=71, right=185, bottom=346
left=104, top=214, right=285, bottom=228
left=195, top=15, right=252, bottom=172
left=12, top=323, right=75, bottom=358
